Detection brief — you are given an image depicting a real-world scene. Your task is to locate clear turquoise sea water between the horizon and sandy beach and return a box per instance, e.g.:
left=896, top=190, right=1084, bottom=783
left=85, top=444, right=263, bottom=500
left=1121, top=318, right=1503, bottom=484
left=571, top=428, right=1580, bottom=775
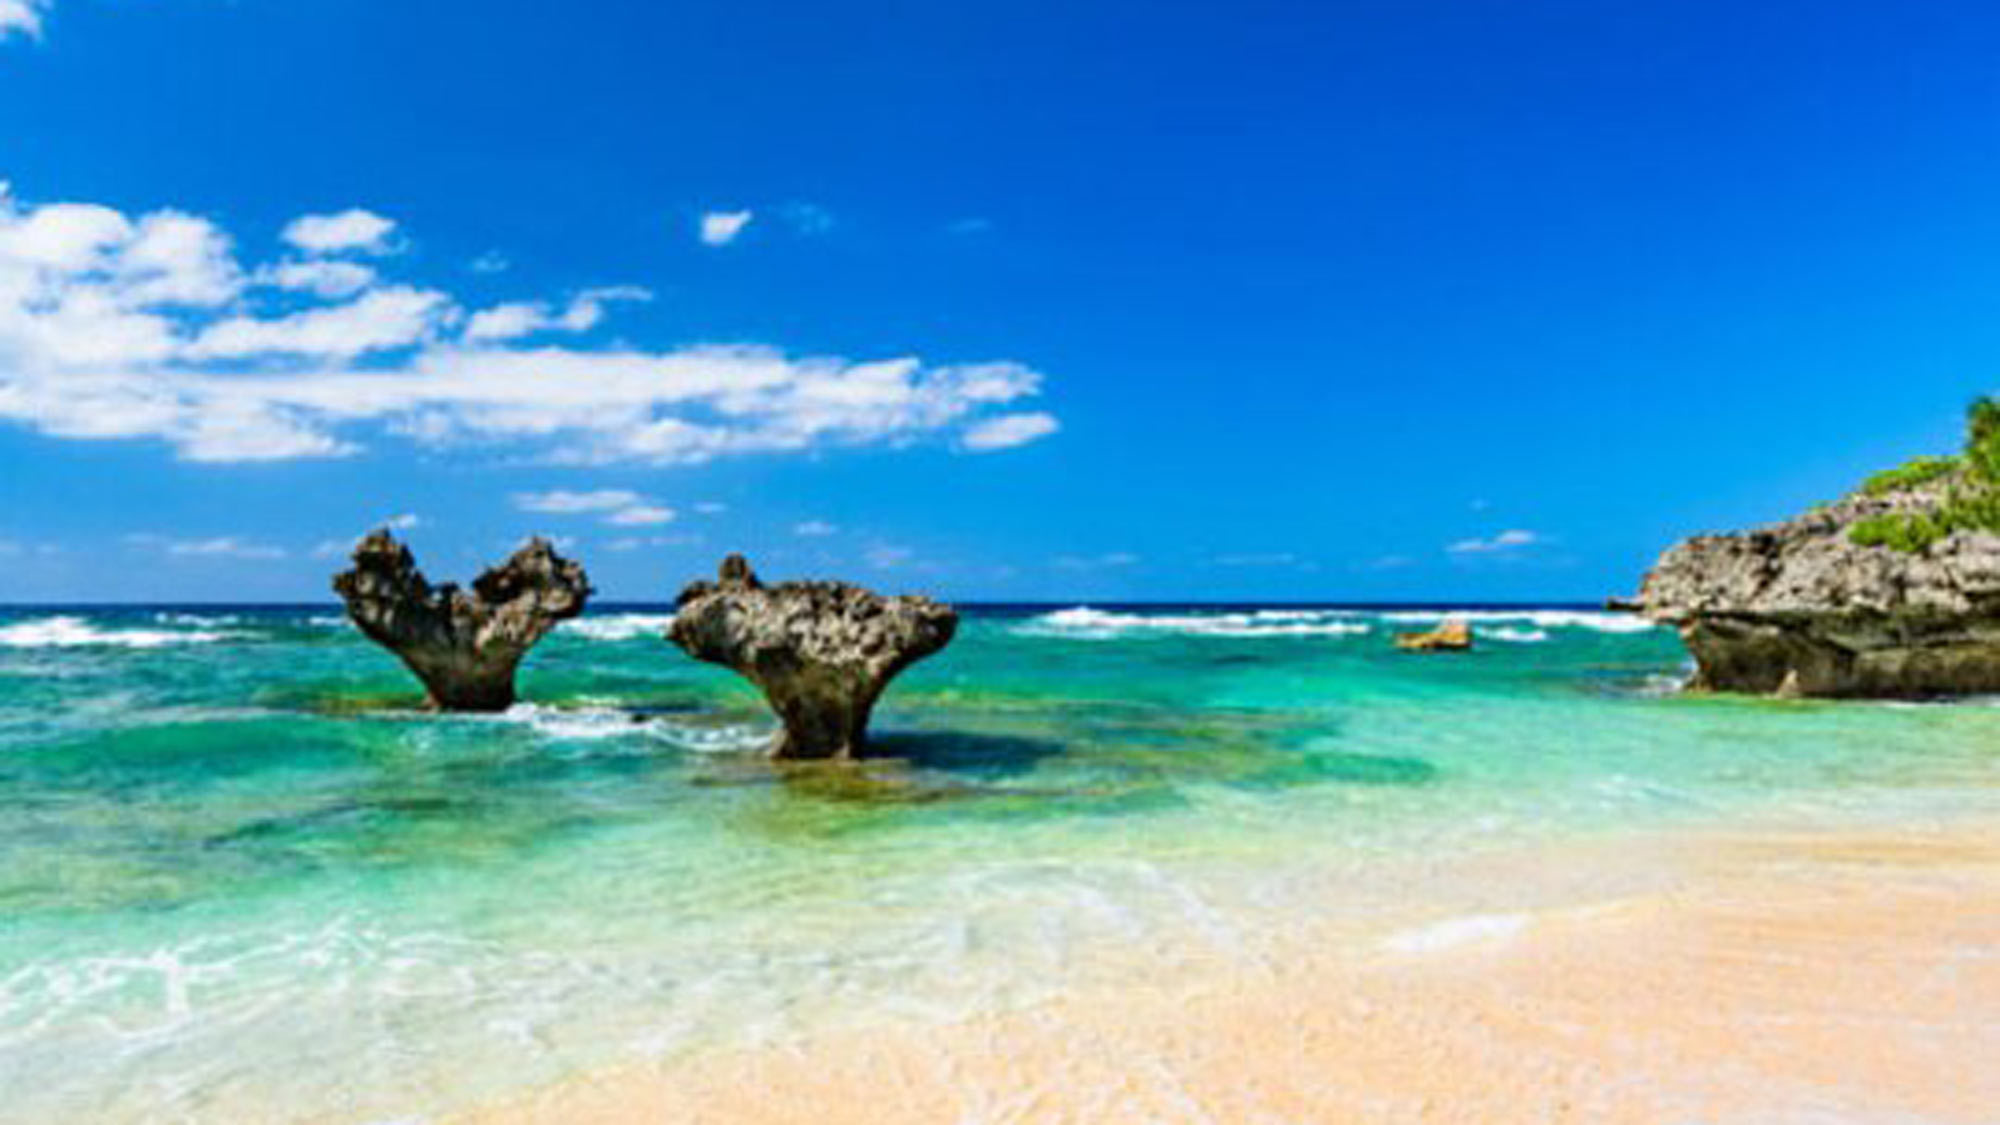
left=0, top=609, right=2000, bottom=1121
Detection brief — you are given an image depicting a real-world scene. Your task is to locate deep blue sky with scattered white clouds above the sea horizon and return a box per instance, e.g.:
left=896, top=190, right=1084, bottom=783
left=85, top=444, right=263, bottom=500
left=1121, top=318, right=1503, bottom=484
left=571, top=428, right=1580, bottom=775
left=0, top=0, right=2000, bottom=601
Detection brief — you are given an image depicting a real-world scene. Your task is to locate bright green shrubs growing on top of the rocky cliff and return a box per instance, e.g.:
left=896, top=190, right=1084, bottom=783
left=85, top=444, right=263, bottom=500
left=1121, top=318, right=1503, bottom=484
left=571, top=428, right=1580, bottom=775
left=1848, top=394, right=2000, bottom=552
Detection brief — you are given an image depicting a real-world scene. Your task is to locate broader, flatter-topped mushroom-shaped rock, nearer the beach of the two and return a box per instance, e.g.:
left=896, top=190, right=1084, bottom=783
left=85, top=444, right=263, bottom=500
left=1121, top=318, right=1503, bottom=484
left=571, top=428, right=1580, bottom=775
left=666, top=554, right=958, bottom=759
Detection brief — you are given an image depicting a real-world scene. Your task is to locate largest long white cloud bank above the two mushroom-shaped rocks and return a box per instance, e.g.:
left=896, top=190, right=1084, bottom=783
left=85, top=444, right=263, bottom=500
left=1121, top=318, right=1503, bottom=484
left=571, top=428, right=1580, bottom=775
left=0, top=188, right=1056, bottom=464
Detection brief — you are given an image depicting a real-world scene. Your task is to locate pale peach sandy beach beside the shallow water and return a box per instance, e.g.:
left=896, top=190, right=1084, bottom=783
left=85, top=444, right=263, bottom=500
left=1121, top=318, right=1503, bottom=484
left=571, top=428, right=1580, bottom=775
left=460, top=827, right=2000, bottom=1125
